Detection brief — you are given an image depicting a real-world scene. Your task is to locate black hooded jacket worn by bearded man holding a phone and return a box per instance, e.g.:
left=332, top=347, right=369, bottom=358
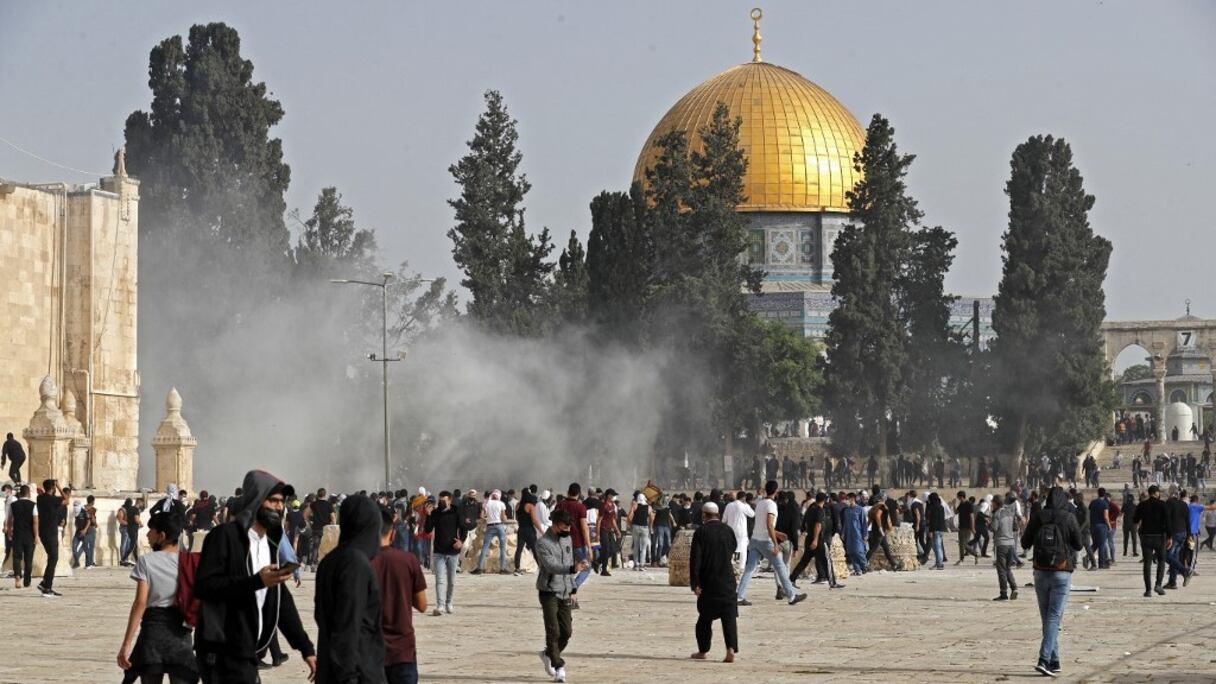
left=193, top=470, right=315, bottom=660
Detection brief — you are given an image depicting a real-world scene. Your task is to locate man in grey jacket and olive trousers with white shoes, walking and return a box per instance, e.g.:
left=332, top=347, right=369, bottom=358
left=536, top=509, right=589, bottom=682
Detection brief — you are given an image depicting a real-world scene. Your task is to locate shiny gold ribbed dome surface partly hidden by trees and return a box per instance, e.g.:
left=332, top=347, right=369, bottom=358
left=634, top=62, right=866, bottom=212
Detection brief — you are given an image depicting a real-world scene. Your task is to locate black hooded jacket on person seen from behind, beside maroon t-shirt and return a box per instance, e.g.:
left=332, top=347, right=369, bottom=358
left=315, top=495, right=384, bottom=684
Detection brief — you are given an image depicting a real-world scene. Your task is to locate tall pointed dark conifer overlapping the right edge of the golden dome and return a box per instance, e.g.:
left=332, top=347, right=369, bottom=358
left=823, top=114, right=919, bottom=460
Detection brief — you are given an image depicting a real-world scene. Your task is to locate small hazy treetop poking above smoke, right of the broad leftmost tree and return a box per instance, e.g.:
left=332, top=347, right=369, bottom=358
left=292, top=187, right=376, bottom=276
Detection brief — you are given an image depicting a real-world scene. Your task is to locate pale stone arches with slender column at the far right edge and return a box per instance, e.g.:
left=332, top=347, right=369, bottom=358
left=1102, top=314, right=1216, bottom=442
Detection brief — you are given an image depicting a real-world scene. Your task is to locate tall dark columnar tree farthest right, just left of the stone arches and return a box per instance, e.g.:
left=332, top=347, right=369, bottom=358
left=991, top=135, right=1115, bottom=459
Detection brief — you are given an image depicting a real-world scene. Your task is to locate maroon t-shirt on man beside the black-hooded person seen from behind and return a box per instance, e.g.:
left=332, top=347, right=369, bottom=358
left=372, top=546, right=427, bottom=666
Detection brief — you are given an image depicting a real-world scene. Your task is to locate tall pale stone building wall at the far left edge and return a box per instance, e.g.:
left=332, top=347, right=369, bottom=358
left=0, top=176, right=139, bottom=490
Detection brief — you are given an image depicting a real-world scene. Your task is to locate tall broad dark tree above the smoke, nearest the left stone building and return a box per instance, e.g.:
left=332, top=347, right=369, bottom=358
left=125, top=23, right=291, bottom=266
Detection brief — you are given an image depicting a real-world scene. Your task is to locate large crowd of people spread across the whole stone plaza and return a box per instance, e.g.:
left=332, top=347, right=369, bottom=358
left=4, top=435, right=1216, bottom=684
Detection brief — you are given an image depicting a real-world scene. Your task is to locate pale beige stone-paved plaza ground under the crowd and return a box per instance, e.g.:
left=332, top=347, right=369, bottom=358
left=0, top=553, right=1216, bottom=684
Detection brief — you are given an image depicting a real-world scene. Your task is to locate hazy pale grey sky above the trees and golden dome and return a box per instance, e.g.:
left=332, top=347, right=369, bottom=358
left=0, top=0, right=1216, bottom=319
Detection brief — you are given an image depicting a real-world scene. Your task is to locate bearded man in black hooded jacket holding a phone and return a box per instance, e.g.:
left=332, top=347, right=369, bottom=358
left=193, top=470, right=316, bottom=684
